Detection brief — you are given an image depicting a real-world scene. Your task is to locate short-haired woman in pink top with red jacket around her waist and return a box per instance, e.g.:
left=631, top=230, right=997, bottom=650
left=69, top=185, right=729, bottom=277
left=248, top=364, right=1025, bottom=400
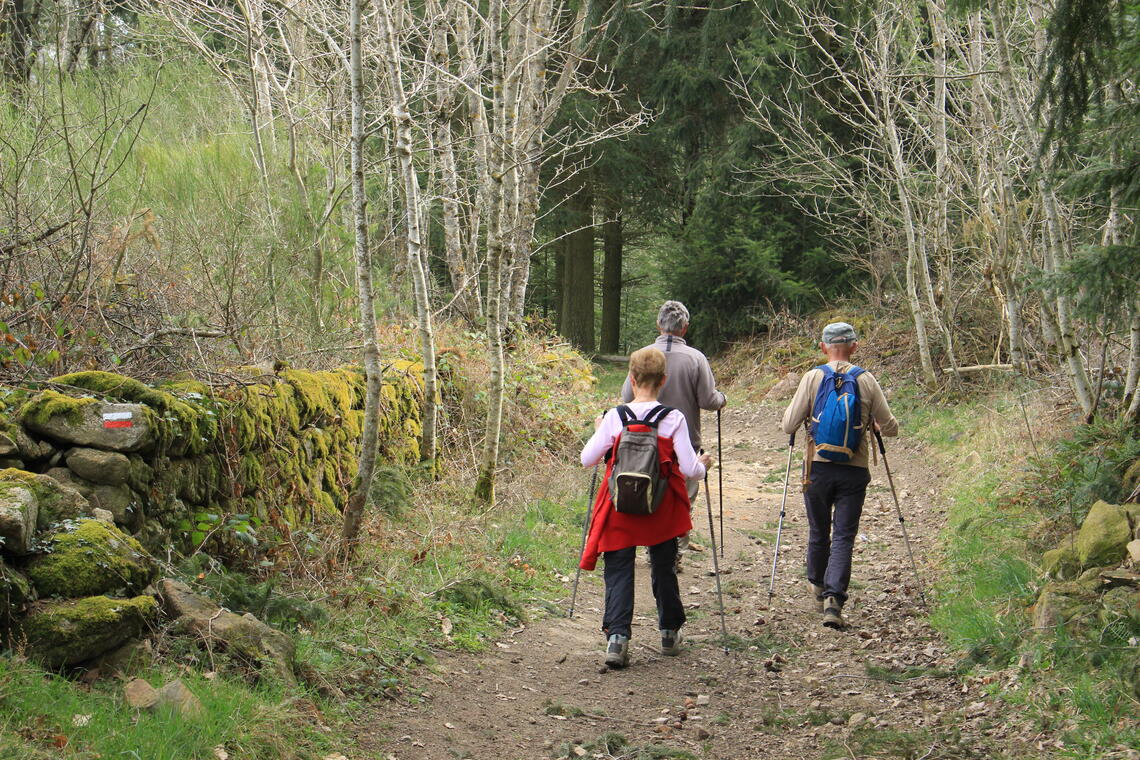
left=579, top=348, right=711, bottom=668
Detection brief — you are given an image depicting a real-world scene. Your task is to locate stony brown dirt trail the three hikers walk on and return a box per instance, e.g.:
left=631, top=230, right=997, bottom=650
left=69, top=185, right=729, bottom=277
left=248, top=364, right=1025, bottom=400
left=359, top=404, right=1041, bottom=760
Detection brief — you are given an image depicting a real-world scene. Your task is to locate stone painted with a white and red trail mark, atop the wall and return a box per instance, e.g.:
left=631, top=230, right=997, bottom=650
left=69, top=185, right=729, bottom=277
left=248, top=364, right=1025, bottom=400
left=22, top=401, right=155, bottom=452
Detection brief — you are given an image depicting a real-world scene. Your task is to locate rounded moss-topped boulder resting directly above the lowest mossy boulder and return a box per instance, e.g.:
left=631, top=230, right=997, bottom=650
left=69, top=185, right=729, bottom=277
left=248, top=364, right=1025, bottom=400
left=27, top=520, right=158, bottom=597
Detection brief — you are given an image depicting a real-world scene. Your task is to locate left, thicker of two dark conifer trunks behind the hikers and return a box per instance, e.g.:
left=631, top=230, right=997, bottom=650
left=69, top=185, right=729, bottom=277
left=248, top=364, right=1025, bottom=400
left=562, top=180, right=594, bottom=353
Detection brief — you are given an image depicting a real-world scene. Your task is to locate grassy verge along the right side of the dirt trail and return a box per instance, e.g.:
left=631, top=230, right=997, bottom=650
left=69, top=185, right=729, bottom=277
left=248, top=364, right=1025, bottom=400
left=899, top=397, right=1140, bottom=758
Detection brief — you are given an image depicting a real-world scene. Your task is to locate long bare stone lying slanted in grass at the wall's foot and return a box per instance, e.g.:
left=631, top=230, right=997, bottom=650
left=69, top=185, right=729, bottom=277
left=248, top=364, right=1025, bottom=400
left=158, top=578, right=296, bottom=684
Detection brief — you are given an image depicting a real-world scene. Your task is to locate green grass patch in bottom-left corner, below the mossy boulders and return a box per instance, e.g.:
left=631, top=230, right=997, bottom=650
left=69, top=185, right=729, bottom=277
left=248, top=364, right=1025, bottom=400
left=0, top=657, right=331, bottom=760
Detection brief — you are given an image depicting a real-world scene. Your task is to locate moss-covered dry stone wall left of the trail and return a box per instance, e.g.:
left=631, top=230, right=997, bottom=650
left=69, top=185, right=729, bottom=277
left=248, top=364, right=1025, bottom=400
left=0, top=361, right=423, bottom=667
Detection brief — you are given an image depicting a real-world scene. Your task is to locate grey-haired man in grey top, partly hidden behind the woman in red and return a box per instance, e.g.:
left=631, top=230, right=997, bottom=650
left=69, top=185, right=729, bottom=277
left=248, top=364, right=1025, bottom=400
left=621, top=301, right=727, bottom=572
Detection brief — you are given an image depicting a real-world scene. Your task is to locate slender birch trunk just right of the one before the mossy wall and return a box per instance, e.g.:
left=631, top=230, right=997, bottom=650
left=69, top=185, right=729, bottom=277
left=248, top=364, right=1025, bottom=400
left=377, top=0, right=438, bottom=461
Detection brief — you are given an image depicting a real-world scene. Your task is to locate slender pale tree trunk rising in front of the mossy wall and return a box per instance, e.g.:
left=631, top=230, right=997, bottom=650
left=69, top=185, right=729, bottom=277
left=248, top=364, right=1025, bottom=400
left=341, top=0, right=382, bottom=555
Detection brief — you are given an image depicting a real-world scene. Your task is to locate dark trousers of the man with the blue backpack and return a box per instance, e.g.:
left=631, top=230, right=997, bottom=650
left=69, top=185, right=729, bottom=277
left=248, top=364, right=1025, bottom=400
left=804, top=461, right=871, bottom=604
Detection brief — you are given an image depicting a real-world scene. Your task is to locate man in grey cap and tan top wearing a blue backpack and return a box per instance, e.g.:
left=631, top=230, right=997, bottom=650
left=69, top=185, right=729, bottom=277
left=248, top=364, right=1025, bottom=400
left=782, top=322, right=898, bottom=628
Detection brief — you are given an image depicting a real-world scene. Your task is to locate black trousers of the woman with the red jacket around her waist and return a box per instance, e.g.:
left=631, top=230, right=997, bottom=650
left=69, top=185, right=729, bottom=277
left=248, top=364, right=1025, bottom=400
left=602, top=538, right=685, bottom=636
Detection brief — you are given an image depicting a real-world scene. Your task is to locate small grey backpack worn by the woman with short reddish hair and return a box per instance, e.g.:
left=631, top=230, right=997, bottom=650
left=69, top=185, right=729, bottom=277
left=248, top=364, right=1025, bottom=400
left=610, top=404, right=673, bottom=515
